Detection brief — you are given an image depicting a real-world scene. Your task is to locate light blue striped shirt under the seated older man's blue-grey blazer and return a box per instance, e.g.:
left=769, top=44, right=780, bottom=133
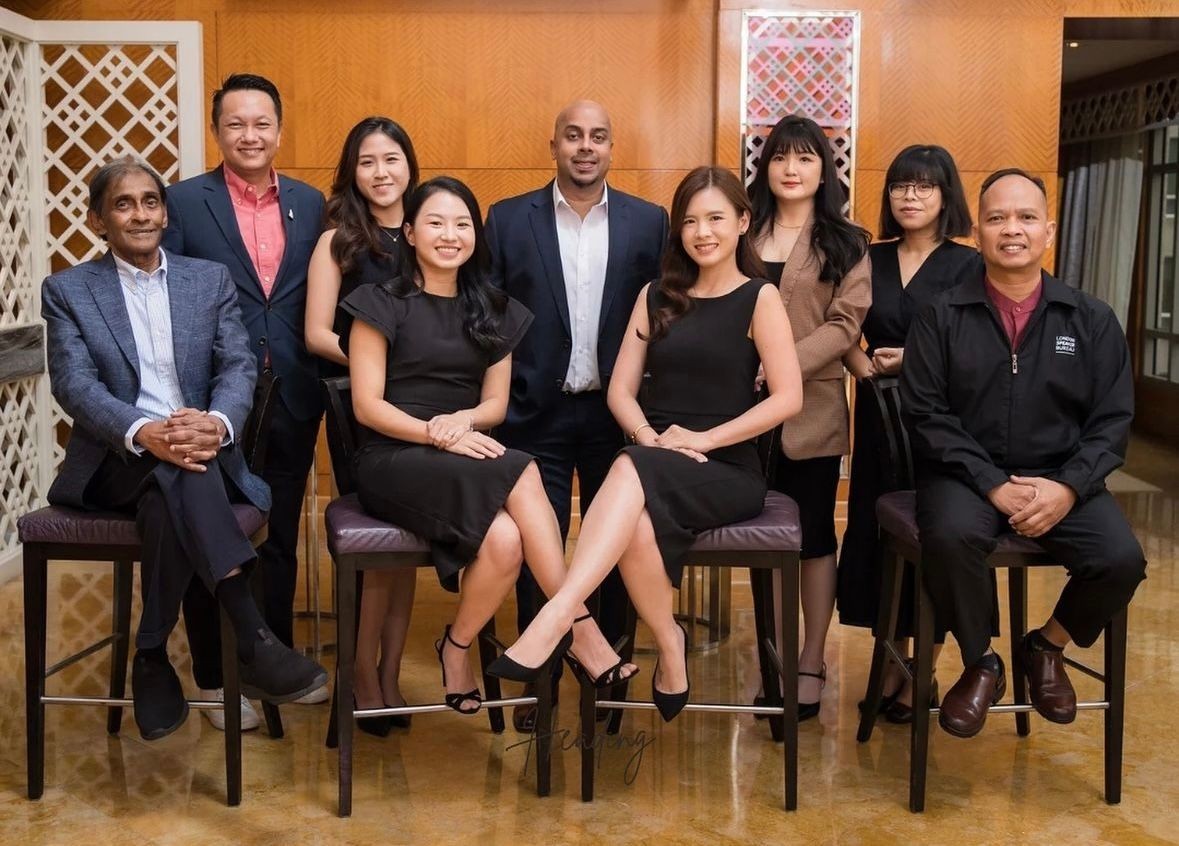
left=112, top=250, right=233, bottom=455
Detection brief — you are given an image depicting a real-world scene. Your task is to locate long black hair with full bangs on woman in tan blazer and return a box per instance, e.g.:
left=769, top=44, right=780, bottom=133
left=749, top=114, right=871, bottom=285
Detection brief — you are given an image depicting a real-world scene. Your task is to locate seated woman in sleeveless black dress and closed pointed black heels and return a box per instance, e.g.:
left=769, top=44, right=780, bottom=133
left=492, top=167, right=802, bottom=720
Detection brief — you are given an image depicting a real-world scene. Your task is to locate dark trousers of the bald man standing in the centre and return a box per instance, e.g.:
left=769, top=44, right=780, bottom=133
left=500, top=391, right=627, bottom=655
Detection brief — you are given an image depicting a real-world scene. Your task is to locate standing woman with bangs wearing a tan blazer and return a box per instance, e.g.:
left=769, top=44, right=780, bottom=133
left=750, top=115, right=872, bottom=720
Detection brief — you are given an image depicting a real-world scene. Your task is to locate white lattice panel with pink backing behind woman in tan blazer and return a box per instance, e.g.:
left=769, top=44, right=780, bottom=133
left=742, top=12, right=859, bottom=209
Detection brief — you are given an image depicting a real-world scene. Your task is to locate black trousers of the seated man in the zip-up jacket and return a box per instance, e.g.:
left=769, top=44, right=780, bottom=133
left=917, top=476, right=1146, bottom=667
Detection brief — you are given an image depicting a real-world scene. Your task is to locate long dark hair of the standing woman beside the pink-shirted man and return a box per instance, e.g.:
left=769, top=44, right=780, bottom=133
left=324, top=118, right=419, bottom=273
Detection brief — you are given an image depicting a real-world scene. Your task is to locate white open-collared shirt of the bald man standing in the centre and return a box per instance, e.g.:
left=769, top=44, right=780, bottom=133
left=553, top=180, right=610, bottom=392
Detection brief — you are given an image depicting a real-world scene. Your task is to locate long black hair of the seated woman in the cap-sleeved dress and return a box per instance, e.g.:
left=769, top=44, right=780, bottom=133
left=382, top=177, right=508, bottom=350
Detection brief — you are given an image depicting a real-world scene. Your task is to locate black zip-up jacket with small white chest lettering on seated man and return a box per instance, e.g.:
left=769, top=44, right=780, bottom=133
left=901, top=273, right=1134, bottom=500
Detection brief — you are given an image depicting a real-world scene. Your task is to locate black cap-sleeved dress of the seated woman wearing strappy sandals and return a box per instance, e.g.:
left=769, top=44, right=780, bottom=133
left=341, top=284, right=533, bottom=590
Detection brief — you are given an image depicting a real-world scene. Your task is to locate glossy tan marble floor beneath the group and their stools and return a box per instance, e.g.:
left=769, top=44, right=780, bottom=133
left=0, top=441, right=1179, bottom=846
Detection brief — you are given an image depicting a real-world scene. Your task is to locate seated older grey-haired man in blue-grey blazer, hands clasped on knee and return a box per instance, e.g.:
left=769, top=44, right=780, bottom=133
left=42, top=158, right=327, bottom=740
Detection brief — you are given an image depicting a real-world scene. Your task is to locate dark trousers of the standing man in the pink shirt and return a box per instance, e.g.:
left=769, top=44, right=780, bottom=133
left=184, top=402, right=320, bottom=689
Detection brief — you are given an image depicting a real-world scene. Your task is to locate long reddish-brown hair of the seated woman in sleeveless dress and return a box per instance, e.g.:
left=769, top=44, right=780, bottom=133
left=639, top=166, right=765, bottom=343
